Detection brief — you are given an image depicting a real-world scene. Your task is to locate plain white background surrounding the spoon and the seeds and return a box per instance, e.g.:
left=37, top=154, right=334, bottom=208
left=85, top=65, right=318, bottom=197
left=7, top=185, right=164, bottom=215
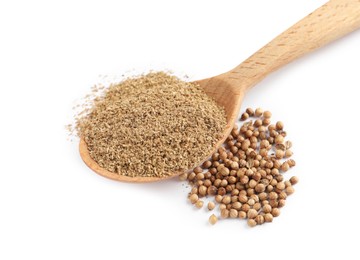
left=0, top=0, right=360, bottom=260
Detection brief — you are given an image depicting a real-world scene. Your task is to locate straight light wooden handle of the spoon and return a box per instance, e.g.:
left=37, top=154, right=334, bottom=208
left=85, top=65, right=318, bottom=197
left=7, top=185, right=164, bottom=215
left=226, top=0, right=360, bottom=89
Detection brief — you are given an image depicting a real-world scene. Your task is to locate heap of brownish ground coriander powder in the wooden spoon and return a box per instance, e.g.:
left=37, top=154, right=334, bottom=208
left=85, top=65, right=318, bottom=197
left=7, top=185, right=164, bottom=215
left=76, top=72, right=226, bottom=177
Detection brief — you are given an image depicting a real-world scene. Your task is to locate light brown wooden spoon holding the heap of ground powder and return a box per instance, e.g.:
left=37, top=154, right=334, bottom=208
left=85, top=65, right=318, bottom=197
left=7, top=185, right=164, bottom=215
left=80, top=0, right=360, bottom=182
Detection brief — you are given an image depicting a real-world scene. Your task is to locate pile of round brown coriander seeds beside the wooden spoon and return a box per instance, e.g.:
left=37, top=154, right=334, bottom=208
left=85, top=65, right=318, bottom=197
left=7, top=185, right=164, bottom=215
left=180, top=108, right=298, bottom=227
